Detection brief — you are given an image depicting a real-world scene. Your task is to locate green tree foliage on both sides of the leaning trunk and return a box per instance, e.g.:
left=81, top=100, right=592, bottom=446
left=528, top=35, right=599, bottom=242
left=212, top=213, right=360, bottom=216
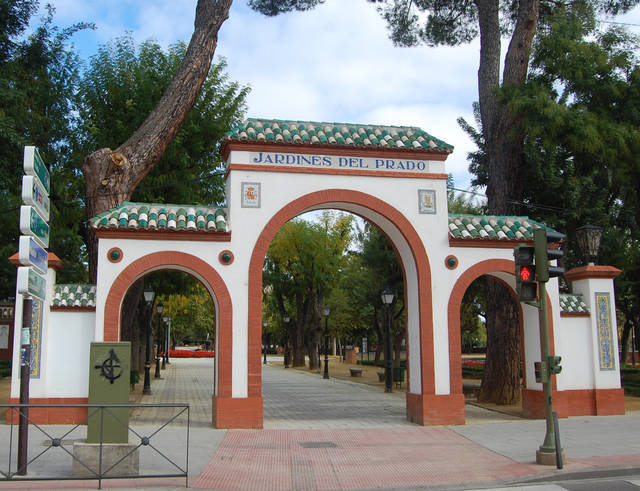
left=78, top=35, right=249, bottom=204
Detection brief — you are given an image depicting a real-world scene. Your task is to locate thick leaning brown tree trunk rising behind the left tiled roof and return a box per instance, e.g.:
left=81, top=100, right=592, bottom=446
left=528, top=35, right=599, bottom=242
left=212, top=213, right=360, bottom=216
left=82, top=0, right=232, bottom=282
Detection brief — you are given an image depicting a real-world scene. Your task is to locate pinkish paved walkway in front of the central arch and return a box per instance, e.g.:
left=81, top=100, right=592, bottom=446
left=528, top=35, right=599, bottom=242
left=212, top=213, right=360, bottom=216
left=192, top=427, right=537, bottom=491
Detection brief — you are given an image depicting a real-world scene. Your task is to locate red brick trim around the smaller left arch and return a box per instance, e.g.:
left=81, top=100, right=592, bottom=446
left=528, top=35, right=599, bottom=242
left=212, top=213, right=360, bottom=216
left=104, top=251, right=233, bottom=397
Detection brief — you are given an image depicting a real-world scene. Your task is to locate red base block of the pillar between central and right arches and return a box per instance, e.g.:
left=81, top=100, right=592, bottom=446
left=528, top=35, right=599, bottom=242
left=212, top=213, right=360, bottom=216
left=407, top=392, right=465, bottom=426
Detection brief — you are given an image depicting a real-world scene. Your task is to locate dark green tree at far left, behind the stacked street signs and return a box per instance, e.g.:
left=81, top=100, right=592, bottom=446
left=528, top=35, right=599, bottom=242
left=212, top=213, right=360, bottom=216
left=0, top=0, right=91, bottom=298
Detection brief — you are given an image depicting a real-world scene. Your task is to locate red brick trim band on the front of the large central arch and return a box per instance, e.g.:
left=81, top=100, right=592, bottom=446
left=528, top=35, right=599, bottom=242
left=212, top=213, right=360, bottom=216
left=248, top=189, right=435, bottom=397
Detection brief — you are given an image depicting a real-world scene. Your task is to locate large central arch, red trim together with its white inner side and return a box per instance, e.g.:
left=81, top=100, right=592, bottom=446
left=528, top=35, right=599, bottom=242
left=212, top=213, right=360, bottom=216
left=247, top=189, right=435, bottom=424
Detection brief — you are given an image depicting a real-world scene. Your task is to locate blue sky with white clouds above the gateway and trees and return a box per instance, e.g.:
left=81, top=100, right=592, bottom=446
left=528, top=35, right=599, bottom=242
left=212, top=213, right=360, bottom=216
left=48, top=0, right=640, bottom=189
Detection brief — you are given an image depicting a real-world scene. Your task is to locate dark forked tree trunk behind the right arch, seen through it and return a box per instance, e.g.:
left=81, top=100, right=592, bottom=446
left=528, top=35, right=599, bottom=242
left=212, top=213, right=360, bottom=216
left=476, top=0, right=540, bottom=404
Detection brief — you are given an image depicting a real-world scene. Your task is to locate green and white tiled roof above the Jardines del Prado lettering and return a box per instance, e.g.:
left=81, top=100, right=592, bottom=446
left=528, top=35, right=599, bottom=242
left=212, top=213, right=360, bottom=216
left=226, top=118, right=453, bottom=153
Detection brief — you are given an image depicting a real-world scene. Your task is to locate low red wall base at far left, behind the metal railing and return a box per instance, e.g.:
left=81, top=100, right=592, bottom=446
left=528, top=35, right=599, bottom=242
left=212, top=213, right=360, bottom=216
left=5, top=397, right=89, bottom=425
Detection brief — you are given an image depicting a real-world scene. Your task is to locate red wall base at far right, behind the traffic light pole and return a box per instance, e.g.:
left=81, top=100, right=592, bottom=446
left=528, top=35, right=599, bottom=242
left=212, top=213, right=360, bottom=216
left=522, top=389, right=624, bottom=419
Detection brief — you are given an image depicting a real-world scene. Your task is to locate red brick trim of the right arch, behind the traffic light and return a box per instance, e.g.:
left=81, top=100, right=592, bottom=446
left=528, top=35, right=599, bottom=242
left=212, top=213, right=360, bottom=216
left=447, top=259, right=555, bottom=394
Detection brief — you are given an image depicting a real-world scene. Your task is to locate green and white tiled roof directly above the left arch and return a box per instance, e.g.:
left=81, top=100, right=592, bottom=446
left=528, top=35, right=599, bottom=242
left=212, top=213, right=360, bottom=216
left=91, top=201, right=227, bottom=232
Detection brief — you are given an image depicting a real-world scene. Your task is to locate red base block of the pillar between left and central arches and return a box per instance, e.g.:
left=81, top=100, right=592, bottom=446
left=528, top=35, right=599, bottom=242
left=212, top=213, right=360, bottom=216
left=211, top=396, right=264, bottom=429
